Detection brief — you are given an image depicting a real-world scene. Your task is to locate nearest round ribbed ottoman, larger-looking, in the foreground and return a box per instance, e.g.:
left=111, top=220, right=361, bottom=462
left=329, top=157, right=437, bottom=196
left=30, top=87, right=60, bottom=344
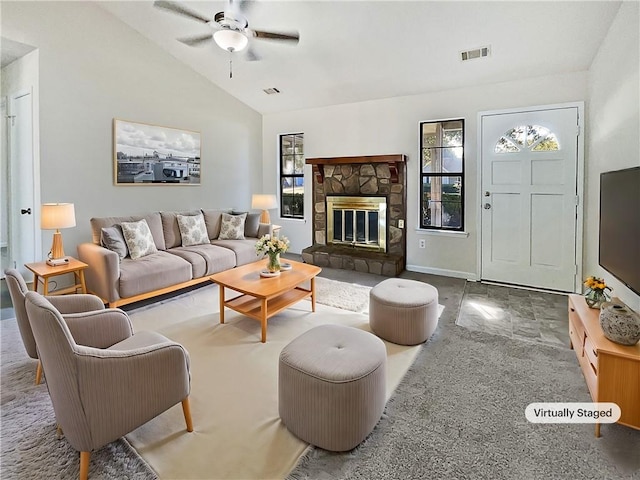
left=278, top=325, right=387, bottom=452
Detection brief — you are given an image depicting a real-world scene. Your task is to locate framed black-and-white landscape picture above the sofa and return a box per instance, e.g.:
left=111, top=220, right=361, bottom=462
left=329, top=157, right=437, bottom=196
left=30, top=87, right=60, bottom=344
left=113, top=118, right=200, bottom=185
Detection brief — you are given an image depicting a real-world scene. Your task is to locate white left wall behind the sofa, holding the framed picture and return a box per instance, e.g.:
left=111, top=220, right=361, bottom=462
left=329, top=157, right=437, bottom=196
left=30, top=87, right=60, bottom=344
left=1, top=2, right=262, bottom=256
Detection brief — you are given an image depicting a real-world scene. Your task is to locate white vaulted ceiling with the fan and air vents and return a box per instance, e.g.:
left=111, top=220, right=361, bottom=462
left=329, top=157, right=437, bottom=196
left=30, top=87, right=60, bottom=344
left=100, top=0, right=620, bottom=113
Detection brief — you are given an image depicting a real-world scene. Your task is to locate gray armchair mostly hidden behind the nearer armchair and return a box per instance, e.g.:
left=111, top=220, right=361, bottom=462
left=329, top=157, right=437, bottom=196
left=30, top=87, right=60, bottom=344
left=4, top=268, right=104, bottom=385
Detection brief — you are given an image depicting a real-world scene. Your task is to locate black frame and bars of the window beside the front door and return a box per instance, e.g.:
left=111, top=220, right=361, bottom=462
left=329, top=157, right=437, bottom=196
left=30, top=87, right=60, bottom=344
left=418, top=117, right=466, bottom=233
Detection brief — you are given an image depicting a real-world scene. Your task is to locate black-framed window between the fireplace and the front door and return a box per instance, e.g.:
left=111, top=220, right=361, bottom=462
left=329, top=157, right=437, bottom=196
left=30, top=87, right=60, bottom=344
left=420, top=119, right=464, bottom=231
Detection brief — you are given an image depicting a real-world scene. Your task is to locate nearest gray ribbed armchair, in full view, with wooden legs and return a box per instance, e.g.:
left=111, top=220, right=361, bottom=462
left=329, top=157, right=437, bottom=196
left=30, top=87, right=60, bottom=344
left=25, top=292, right=193, bottom=480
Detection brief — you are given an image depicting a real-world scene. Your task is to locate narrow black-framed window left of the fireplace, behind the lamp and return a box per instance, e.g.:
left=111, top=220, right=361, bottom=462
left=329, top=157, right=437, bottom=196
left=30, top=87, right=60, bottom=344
left=280, top=133, right=304, bottom=218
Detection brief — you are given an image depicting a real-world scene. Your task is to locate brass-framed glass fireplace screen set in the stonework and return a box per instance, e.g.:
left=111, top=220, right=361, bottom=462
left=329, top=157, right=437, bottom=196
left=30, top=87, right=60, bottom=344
left=327, top=196, right=387, bottom=252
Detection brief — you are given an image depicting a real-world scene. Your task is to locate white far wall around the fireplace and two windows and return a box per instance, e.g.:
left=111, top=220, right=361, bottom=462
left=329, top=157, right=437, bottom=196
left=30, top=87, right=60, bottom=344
left=263, top=72, right=587, bottom=279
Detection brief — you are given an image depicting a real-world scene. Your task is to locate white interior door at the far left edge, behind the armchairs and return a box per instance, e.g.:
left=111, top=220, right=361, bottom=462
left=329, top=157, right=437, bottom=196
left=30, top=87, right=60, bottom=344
left=7, top=90, right=38, bottom=278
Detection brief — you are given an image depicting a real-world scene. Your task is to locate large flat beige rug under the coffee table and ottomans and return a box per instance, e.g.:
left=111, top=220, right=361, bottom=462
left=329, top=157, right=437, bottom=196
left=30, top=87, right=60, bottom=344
left=127, top=286, right=420, bottom=479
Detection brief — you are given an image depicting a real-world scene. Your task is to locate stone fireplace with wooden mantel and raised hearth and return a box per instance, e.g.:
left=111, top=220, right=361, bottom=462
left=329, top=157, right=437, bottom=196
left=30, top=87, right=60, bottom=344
left=302, top=155, right=406, bottom=276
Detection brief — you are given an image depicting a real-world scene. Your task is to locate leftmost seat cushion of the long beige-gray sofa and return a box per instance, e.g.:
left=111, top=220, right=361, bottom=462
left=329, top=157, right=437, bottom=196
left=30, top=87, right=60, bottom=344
left=119, top=251, right=192, bottom=298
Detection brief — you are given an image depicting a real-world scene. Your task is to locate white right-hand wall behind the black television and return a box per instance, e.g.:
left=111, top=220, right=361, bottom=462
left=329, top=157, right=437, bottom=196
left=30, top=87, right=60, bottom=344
left=584, top=1, right=640, bottom=311
